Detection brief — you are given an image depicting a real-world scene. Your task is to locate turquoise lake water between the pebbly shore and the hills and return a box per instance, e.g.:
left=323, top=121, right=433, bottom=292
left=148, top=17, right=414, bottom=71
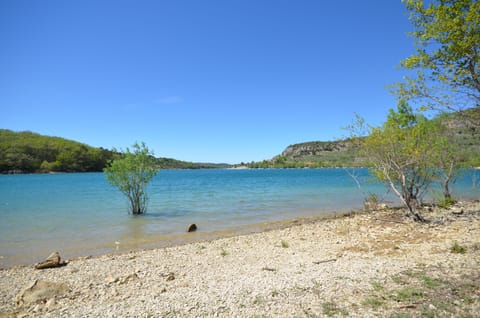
left=0, top=169, right=480, bottom=266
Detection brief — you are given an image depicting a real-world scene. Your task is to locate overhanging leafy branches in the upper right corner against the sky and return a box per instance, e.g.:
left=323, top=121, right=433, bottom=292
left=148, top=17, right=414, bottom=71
left=394, top=0, right=480, bottom=120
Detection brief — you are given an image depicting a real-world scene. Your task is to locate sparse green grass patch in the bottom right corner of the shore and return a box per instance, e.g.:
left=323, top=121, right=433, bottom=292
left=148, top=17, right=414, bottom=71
left=359, top=268, right=480, bottom=317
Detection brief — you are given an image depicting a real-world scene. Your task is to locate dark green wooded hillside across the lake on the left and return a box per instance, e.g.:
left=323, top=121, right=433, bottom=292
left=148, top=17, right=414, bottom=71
left=0, top=129, right=228, bottom=173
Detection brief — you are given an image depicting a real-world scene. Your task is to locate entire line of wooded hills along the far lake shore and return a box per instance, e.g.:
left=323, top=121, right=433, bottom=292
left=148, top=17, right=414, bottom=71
left=0, top=107, right=480, bottom=174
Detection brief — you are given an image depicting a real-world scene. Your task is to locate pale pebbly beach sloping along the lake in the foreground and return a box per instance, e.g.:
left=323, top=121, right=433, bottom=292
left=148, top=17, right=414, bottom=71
left=0, top=202, right=480, bottom=317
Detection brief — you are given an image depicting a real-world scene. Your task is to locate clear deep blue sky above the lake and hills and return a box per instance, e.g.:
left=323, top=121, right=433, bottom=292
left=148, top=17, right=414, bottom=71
left=0, top=0, right=413, bottom=163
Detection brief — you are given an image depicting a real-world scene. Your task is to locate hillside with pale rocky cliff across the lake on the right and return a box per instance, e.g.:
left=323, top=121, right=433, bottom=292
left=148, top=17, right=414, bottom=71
left=248, top=108, right=480, bottom=168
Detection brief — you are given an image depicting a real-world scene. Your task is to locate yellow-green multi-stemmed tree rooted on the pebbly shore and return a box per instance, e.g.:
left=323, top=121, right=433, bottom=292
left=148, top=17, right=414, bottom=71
left=358, top=101, right=436, bottom=222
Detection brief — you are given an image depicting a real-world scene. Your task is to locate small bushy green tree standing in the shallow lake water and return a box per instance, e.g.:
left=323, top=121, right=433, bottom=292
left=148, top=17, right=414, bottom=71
left=104, top=142, right=159, bottom=215
